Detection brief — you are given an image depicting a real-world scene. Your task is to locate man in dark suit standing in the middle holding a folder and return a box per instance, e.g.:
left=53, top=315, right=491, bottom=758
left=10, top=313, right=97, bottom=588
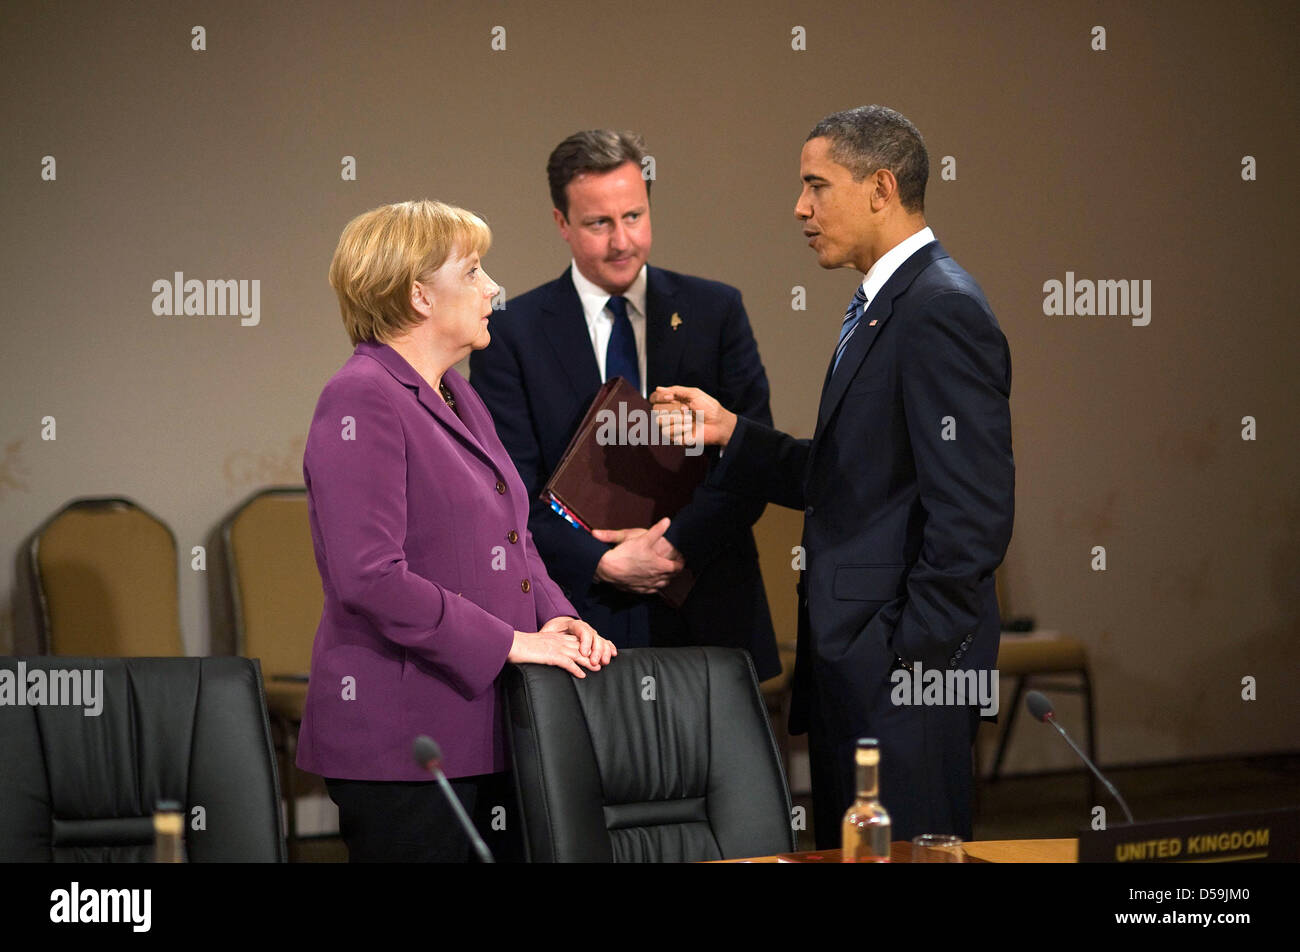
left=469, top=130, right=780, bottom=679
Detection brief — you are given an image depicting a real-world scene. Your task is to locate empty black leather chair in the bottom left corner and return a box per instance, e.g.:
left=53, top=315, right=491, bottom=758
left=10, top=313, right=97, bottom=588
left=0, top=657, right=285, bottom=862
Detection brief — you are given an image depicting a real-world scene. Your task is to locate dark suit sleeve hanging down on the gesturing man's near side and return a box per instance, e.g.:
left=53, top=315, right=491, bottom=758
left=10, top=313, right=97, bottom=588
left=891, top=293, right=1015, bottom=667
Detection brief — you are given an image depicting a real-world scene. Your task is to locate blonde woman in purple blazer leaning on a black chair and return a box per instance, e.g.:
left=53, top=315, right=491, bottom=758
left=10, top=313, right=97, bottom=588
left=298, top=200, right=618, bottom=861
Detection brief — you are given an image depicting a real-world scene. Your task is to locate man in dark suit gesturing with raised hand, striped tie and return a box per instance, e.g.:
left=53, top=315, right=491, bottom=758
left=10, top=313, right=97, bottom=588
left=653, top=105, right=1015, bottom=849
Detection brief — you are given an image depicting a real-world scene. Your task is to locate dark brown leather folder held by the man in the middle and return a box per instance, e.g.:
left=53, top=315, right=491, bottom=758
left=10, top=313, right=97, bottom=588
left=541, top=377, right=709, bottom=606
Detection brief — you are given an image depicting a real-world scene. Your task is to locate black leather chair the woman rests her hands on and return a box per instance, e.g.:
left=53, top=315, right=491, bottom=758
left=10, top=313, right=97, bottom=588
left=506, top=648, right=794, bottom=862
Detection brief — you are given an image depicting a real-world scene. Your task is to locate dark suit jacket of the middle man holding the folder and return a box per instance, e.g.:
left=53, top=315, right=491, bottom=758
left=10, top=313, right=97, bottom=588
left=469, top=268, right=780, bottom=679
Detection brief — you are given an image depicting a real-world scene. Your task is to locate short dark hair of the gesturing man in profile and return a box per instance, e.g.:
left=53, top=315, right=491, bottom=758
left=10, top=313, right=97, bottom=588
left=809, top=105, right=930, bottom=212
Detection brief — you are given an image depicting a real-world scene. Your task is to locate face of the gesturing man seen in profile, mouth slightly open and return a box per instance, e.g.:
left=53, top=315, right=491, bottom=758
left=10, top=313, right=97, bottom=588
left=794, top=137, right=876, bottom=272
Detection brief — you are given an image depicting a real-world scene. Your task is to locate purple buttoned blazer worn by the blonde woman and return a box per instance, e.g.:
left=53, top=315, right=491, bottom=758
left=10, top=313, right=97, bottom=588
left=298, top=342, right=576, bottom=780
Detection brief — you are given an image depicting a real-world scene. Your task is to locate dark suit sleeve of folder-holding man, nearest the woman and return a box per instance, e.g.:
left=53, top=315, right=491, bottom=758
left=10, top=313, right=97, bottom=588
left=469, top=330, right=610, bottom=598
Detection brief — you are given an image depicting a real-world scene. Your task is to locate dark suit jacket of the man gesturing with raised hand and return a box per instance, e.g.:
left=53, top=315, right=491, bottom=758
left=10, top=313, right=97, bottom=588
left=710, top=242, right=1015, bottom=743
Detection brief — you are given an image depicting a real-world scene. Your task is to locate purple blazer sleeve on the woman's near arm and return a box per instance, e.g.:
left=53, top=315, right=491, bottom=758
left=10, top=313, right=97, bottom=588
left=303, top=378, right=515, bottom=698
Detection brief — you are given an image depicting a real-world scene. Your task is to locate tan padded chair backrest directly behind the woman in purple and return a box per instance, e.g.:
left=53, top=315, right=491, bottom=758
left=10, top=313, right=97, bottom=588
left=222, top=488, right=325, bottom=678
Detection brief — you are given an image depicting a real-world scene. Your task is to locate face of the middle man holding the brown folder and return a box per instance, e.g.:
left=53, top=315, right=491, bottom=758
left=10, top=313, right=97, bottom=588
left=553, top=161, right=650, bottom=294
